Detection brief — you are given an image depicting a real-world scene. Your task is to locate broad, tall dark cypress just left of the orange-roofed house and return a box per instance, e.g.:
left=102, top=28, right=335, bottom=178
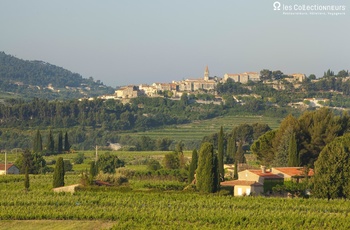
left=196, top=142, right=219, bottom=193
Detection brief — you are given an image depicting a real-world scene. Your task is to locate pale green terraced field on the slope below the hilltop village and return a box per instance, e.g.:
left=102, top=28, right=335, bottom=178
left=123, top=116, right=280, bottom=141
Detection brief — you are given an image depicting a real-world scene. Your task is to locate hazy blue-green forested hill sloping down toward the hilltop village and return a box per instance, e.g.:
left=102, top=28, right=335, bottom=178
left=0, top=52, right=114, bottom=99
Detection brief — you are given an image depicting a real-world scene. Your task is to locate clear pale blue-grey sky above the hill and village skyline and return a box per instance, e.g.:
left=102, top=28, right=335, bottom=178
left=0, top=0, right=350, bottom=87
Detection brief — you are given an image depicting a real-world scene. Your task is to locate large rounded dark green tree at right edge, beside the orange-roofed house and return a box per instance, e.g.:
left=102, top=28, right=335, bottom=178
left=313, top=134, right=350, bottom=200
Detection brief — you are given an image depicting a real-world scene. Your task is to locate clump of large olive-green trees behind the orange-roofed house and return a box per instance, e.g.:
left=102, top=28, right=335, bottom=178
left=251, top=108, right=350, bottom=167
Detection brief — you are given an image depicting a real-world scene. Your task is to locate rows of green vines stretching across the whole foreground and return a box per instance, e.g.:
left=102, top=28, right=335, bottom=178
left=0, top=174, right=350, bottom=229
